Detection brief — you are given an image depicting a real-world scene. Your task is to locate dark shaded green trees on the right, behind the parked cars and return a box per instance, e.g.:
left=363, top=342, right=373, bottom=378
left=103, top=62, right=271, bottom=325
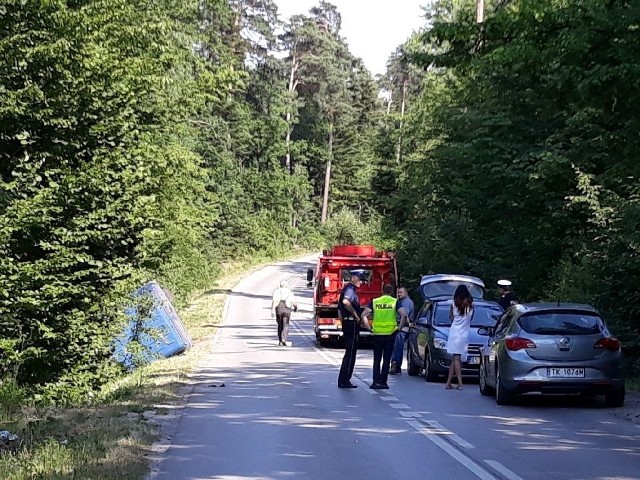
left=383, top=0, right=640, bottom=372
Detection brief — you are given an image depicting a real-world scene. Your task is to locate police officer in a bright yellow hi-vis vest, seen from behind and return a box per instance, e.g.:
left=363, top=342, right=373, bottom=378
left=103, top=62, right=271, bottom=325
left=362, top=285, right=398, bottom=390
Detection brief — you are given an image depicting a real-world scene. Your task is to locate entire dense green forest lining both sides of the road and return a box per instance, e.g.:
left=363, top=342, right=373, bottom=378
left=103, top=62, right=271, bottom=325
left=0, top=0, right=640, bottom=402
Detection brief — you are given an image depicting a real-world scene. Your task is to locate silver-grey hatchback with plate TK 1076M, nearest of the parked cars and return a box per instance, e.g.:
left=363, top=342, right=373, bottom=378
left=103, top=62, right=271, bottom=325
left=478, top=303, right=625, bottom=407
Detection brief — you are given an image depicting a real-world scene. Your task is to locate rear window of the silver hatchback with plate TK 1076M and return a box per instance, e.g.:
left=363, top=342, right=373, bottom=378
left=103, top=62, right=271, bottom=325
left=518, top=312, right=604, bottom=335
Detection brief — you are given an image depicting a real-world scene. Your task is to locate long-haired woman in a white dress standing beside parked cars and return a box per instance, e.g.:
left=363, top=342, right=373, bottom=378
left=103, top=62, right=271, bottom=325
left=444, top=285, right=473, bottom=390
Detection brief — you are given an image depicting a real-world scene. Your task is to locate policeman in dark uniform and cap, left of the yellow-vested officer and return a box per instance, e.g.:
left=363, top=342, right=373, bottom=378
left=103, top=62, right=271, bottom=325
left=338, top=272, right=362, bottom=388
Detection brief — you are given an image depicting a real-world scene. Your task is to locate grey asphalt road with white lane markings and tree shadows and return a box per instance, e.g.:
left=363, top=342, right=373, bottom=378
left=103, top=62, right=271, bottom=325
left=150, top=259, right=640, bottom=480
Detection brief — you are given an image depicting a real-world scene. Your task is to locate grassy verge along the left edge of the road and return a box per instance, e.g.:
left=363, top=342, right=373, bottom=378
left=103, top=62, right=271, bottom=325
left=0, top=252, right=312, bottom=480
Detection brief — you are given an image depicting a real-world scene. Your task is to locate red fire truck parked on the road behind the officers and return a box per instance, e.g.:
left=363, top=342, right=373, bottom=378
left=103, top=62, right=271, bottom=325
left=307, top=245, right=398, bottom=344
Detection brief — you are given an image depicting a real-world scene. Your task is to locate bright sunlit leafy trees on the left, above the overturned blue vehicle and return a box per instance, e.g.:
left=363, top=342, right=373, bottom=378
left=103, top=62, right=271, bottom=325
left=0, top=1, right=240, bottom=401
